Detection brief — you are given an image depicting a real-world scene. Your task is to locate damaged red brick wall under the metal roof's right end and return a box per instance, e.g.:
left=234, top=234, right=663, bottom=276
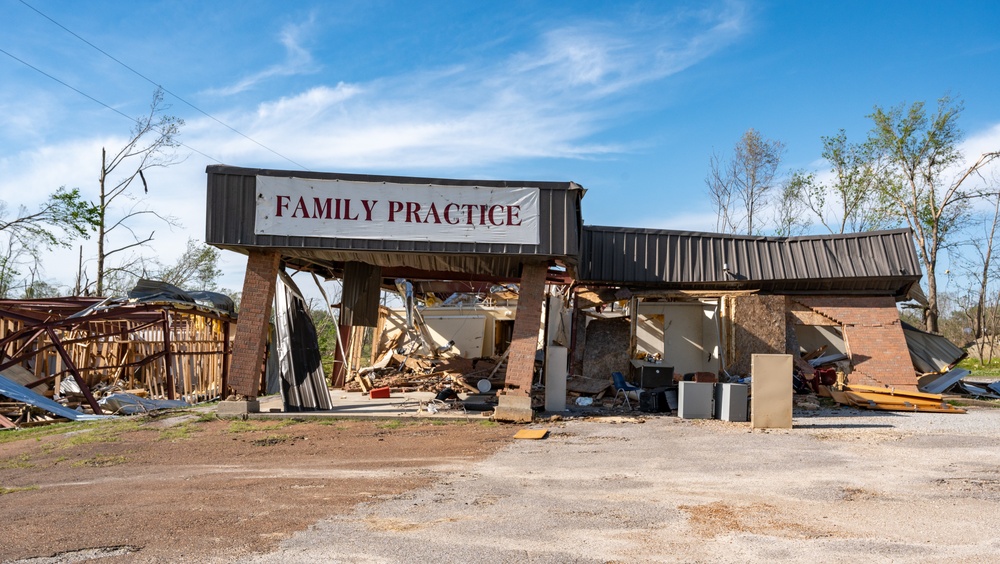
left=793, top=296, right=917, bottom=390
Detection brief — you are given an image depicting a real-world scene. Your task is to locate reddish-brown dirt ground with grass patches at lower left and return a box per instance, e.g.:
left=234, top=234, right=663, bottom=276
left=0, top=413, right=514, bottom=562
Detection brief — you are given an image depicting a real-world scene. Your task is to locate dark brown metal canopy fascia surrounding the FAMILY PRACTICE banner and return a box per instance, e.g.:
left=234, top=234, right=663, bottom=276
left=205, top=165, right=583, bottom=262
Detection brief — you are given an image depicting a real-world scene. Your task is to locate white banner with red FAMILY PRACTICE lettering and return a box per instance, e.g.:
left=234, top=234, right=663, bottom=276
left=254, top=176, right=539, bottom=245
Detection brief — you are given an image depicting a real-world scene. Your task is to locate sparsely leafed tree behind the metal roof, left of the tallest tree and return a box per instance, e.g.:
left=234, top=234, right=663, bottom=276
left=792, top=129, right=900, bottom=233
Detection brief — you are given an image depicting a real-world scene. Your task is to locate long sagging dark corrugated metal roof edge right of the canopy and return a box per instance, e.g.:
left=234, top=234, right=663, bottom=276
left=579, top=226, right=921, bottom=292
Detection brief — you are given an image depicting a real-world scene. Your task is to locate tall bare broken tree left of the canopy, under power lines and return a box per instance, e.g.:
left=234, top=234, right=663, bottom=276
left=95, top=88, right=184, bottom=295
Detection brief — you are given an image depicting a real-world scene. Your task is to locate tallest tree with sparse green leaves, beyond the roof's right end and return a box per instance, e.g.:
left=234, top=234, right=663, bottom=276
left=869, top=96, right=1000, bottom=332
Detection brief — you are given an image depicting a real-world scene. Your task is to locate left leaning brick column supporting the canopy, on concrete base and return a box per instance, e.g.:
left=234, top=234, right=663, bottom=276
left=229, top=250, right=281, bottom=398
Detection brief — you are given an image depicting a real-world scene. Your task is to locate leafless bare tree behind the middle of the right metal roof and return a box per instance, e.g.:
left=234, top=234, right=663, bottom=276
left=705, top=128, right=785, bottom=235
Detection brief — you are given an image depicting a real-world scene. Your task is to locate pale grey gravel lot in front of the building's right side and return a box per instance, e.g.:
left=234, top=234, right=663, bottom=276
left=245, top=408, right=1000, bottom=563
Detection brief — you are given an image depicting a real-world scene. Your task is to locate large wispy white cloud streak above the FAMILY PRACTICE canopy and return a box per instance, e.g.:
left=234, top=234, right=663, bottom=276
left=191, top=4, right=746, bottom=170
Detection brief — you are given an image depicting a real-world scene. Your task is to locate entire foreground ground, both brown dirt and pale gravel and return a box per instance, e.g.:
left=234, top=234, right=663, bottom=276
left=0, top=407, right=1000, bottom=564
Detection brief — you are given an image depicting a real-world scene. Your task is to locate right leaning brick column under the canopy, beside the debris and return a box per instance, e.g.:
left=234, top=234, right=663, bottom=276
left=507, top=263, right=549, bottom=395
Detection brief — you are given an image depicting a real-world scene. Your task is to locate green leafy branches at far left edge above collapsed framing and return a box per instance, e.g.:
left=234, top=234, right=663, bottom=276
left=0, top=187, right=98, bottom=298
